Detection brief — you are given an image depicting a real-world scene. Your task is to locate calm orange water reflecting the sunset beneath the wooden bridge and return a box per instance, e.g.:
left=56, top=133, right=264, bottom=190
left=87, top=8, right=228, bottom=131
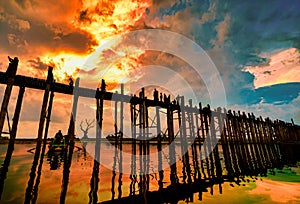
left=0, top=143, right=300, bottom=203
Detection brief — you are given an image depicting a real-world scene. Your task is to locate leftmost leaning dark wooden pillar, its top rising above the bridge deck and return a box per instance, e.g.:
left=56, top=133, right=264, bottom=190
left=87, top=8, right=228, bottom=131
left=0, top=57, right=19, bottom=136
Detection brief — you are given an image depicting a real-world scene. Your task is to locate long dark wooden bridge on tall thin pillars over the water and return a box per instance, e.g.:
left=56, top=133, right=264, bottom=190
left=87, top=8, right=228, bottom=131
left=0, top=58, right=300, bottom=203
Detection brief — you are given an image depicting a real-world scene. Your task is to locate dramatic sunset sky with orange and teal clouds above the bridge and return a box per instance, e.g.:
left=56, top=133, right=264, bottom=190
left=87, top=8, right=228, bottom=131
left=0, top=0, right=300, bottom=137
